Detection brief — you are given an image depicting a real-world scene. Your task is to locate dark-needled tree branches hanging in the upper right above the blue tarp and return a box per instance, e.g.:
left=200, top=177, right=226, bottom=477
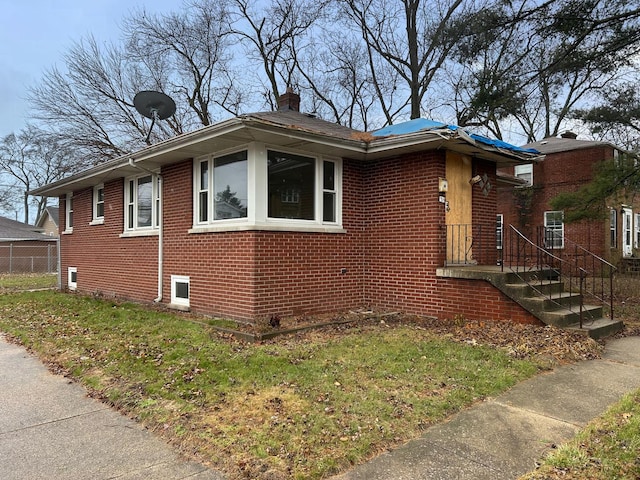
left=450, top=0, right=640, bottom=142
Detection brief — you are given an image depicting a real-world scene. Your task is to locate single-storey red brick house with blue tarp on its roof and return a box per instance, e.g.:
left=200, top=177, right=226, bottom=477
left=31, top=93, right=539, bottom=322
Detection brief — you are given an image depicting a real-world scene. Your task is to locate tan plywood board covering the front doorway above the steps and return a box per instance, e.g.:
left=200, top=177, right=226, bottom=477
left=445, top=152, right=473, bottom=265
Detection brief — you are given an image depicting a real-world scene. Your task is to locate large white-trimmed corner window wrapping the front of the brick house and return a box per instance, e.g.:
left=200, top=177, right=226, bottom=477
left=190, top=142, right=343, bottom=233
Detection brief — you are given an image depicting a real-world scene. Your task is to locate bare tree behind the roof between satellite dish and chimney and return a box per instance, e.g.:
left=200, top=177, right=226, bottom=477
left=124, top=0, right=243, bottom=124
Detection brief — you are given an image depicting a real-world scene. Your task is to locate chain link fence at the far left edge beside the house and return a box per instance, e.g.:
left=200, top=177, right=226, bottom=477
left=0, top=242, right=58, bottom=273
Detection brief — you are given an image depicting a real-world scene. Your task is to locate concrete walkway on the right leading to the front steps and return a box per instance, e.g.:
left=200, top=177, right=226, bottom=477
left=333, top=337, right=640, bottom=480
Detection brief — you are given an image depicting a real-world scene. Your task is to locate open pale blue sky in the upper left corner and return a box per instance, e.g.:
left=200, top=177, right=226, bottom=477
left=0, top=0, right=182, bottom=138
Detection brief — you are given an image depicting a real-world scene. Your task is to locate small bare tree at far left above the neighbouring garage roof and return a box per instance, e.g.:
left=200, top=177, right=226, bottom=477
left=0, top=126, right=86, bottom=223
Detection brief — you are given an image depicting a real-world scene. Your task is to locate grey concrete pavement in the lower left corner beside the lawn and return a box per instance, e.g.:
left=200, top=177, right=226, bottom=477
left=0, top=335, right=224, bottom=480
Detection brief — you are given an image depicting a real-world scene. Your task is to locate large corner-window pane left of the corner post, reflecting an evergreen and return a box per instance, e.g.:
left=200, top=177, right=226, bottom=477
left=214, top=151, right=247, bottom=220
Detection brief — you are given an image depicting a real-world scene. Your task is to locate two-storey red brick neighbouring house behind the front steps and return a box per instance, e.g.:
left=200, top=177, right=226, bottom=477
left=498, top=132, right=640, bottom=264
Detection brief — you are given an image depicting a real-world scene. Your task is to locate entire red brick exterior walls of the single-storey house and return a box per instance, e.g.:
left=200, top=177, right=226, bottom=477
left=60, top=151, right=544, bottom=322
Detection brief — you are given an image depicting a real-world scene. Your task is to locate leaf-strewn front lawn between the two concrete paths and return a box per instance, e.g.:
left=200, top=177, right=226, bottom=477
left=0, top=291, right=540, bottom=479
